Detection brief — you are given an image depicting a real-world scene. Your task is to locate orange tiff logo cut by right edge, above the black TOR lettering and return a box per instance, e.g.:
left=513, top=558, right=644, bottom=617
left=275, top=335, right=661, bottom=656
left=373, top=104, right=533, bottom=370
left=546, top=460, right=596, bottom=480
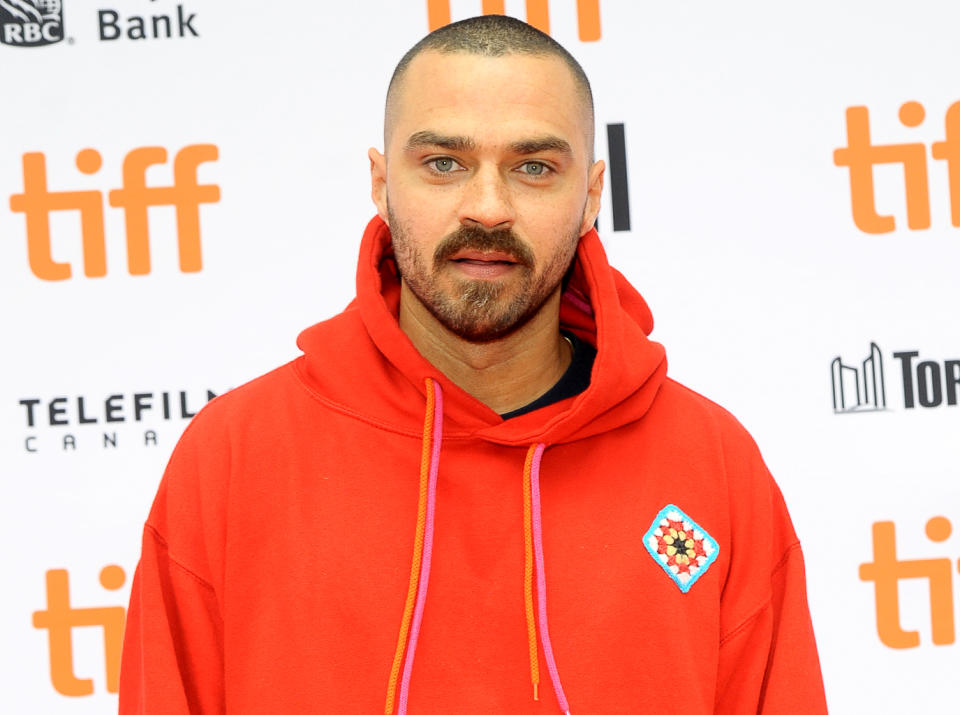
left=833, top=102, right=960, bottom=233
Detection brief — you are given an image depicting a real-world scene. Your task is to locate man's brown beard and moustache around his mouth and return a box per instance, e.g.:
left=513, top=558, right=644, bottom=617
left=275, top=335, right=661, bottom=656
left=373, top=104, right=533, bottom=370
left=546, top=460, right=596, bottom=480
left=389, top=208, right=579, bottom=343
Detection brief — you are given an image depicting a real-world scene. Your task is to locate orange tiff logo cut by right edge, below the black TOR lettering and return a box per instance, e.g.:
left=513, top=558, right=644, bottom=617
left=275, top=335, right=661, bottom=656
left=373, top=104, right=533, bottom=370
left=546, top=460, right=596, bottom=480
left=860, top=516, right=955, bottom=648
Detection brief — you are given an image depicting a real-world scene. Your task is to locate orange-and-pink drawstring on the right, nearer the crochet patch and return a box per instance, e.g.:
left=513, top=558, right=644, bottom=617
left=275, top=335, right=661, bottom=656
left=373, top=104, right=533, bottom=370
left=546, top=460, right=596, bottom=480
left=523, top=443, right=570, bottom=715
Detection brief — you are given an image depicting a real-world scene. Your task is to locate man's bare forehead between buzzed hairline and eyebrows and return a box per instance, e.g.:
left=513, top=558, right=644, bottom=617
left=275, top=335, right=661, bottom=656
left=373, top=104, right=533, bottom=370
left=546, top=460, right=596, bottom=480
left=387, top=51, right=589, bottom=155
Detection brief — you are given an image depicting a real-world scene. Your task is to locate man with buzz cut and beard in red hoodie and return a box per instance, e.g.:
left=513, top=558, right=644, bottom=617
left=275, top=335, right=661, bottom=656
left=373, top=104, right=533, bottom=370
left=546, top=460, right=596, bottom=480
left=120, top=16, right=826, bottom=715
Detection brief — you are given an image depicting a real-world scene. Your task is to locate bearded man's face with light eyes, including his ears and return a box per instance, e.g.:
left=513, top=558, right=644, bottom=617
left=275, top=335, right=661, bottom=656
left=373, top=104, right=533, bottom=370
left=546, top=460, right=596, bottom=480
left=370, top=51, right=603, bottom=342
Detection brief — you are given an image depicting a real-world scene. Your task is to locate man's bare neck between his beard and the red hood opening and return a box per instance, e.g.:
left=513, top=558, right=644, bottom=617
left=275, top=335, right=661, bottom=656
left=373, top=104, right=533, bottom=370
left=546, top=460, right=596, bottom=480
left=399, top=282, right=571, bottom=414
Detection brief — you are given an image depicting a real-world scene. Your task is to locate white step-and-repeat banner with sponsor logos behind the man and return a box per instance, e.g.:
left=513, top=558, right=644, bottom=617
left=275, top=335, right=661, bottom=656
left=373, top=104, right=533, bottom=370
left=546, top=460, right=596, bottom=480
left=0, top=0, right=960, bottom=715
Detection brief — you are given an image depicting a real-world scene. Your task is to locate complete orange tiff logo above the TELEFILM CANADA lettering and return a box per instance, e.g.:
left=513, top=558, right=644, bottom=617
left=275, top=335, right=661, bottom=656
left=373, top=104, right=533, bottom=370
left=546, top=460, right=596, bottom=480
left=10, top=144, right=220, bottom=281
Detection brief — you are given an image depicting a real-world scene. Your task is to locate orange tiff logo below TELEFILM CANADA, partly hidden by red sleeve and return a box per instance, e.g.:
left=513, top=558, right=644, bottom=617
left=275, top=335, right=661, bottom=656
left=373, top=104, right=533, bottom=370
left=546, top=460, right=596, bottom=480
left=33, top=566, right=127, bottom=696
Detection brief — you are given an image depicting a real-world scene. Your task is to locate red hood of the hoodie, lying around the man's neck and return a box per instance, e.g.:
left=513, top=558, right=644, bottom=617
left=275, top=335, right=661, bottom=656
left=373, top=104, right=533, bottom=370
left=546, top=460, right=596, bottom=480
left=297, top=217, right=666, bottom=445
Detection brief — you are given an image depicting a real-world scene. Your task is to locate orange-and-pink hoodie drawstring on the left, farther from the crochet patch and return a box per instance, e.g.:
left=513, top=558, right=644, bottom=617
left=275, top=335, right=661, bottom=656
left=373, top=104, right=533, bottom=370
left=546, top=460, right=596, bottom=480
left=384, top=377, right=443, bottom=715
